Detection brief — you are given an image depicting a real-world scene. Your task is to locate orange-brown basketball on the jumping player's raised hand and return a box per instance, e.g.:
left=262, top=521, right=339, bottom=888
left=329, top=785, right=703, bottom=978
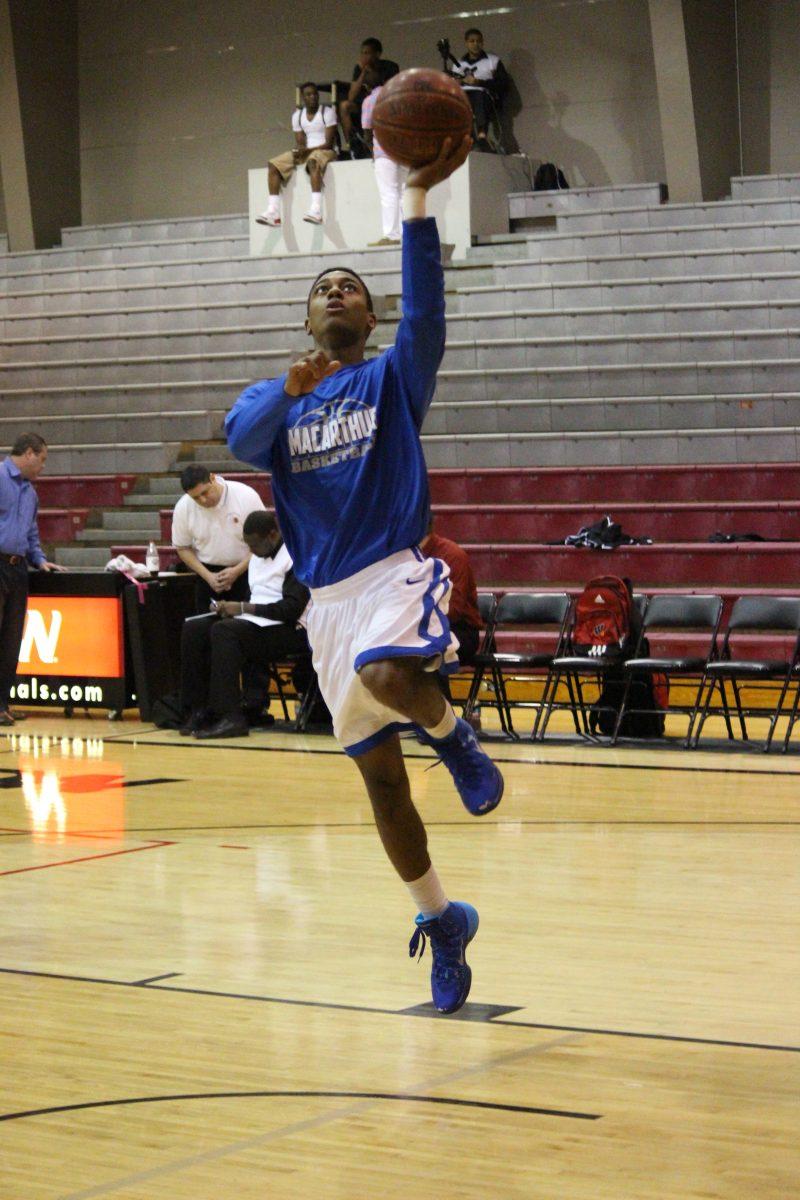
left=372, top=67, right=473, bottom=167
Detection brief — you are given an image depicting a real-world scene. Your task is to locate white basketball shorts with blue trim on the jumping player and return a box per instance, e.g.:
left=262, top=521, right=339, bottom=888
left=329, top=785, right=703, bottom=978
left=306, top=547, right=458, bottom=757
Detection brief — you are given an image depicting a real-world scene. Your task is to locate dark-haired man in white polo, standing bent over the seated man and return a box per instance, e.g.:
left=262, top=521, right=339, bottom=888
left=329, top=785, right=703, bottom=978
left=173, top=463, right=264, bottom=612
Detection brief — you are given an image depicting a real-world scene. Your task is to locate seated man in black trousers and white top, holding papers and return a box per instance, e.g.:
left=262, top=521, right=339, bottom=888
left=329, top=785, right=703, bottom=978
left=181, top=512, right=309, bottom=738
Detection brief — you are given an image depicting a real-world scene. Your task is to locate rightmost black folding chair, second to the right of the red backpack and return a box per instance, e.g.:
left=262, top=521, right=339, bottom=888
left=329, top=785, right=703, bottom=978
left=691, top=596, right=800, bottom=752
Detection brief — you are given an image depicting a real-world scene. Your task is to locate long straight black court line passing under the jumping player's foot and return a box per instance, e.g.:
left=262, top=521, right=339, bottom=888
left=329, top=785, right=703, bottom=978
left=0, top=967, right=800, bottom=1054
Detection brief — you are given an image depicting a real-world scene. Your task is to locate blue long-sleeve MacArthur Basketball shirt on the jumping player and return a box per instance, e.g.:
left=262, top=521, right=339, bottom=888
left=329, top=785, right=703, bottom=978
left=225, top=217, right=445, bottom=588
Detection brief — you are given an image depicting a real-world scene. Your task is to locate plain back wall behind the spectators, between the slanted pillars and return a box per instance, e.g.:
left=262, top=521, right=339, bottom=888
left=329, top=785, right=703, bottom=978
left=79, top=0, right=663, bottom=223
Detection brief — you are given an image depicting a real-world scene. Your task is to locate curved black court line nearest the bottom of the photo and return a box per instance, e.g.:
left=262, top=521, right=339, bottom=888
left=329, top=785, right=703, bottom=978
left=0, top=1091, right=601, bottom=1121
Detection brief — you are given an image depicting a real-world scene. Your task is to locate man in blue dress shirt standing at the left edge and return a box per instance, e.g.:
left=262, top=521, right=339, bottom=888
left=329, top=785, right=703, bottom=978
left=0, top=433, right=64, bottom=725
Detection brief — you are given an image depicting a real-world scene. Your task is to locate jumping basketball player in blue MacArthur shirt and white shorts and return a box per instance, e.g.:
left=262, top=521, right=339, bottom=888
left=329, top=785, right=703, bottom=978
left=225, top=137, right=503, bottom=1013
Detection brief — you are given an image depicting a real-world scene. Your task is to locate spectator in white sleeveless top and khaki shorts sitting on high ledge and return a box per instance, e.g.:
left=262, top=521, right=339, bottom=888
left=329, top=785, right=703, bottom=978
left=255, top=83, right=337, bottom=227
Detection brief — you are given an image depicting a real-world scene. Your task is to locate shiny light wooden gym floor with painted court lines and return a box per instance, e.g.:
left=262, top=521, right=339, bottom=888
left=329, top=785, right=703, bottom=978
left=0, top=715, right=800, bottom=1200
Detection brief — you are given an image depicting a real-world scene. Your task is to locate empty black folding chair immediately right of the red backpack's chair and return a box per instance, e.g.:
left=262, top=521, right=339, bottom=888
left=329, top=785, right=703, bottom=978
left=612, top=595, right=729, bottom=748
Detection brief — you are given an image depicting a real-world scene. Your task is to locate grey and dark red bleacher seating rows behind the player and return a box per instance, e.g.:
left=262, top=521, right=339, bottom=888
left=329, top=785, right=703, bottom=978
left=0, top=176, right=800, bottom=619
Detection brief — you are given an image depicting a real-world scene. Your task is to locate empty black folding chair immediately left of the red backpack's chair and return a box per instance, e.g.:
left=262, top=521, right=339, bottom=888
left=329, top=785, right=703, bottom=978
left=473, top=592, right=570, bottom=740
